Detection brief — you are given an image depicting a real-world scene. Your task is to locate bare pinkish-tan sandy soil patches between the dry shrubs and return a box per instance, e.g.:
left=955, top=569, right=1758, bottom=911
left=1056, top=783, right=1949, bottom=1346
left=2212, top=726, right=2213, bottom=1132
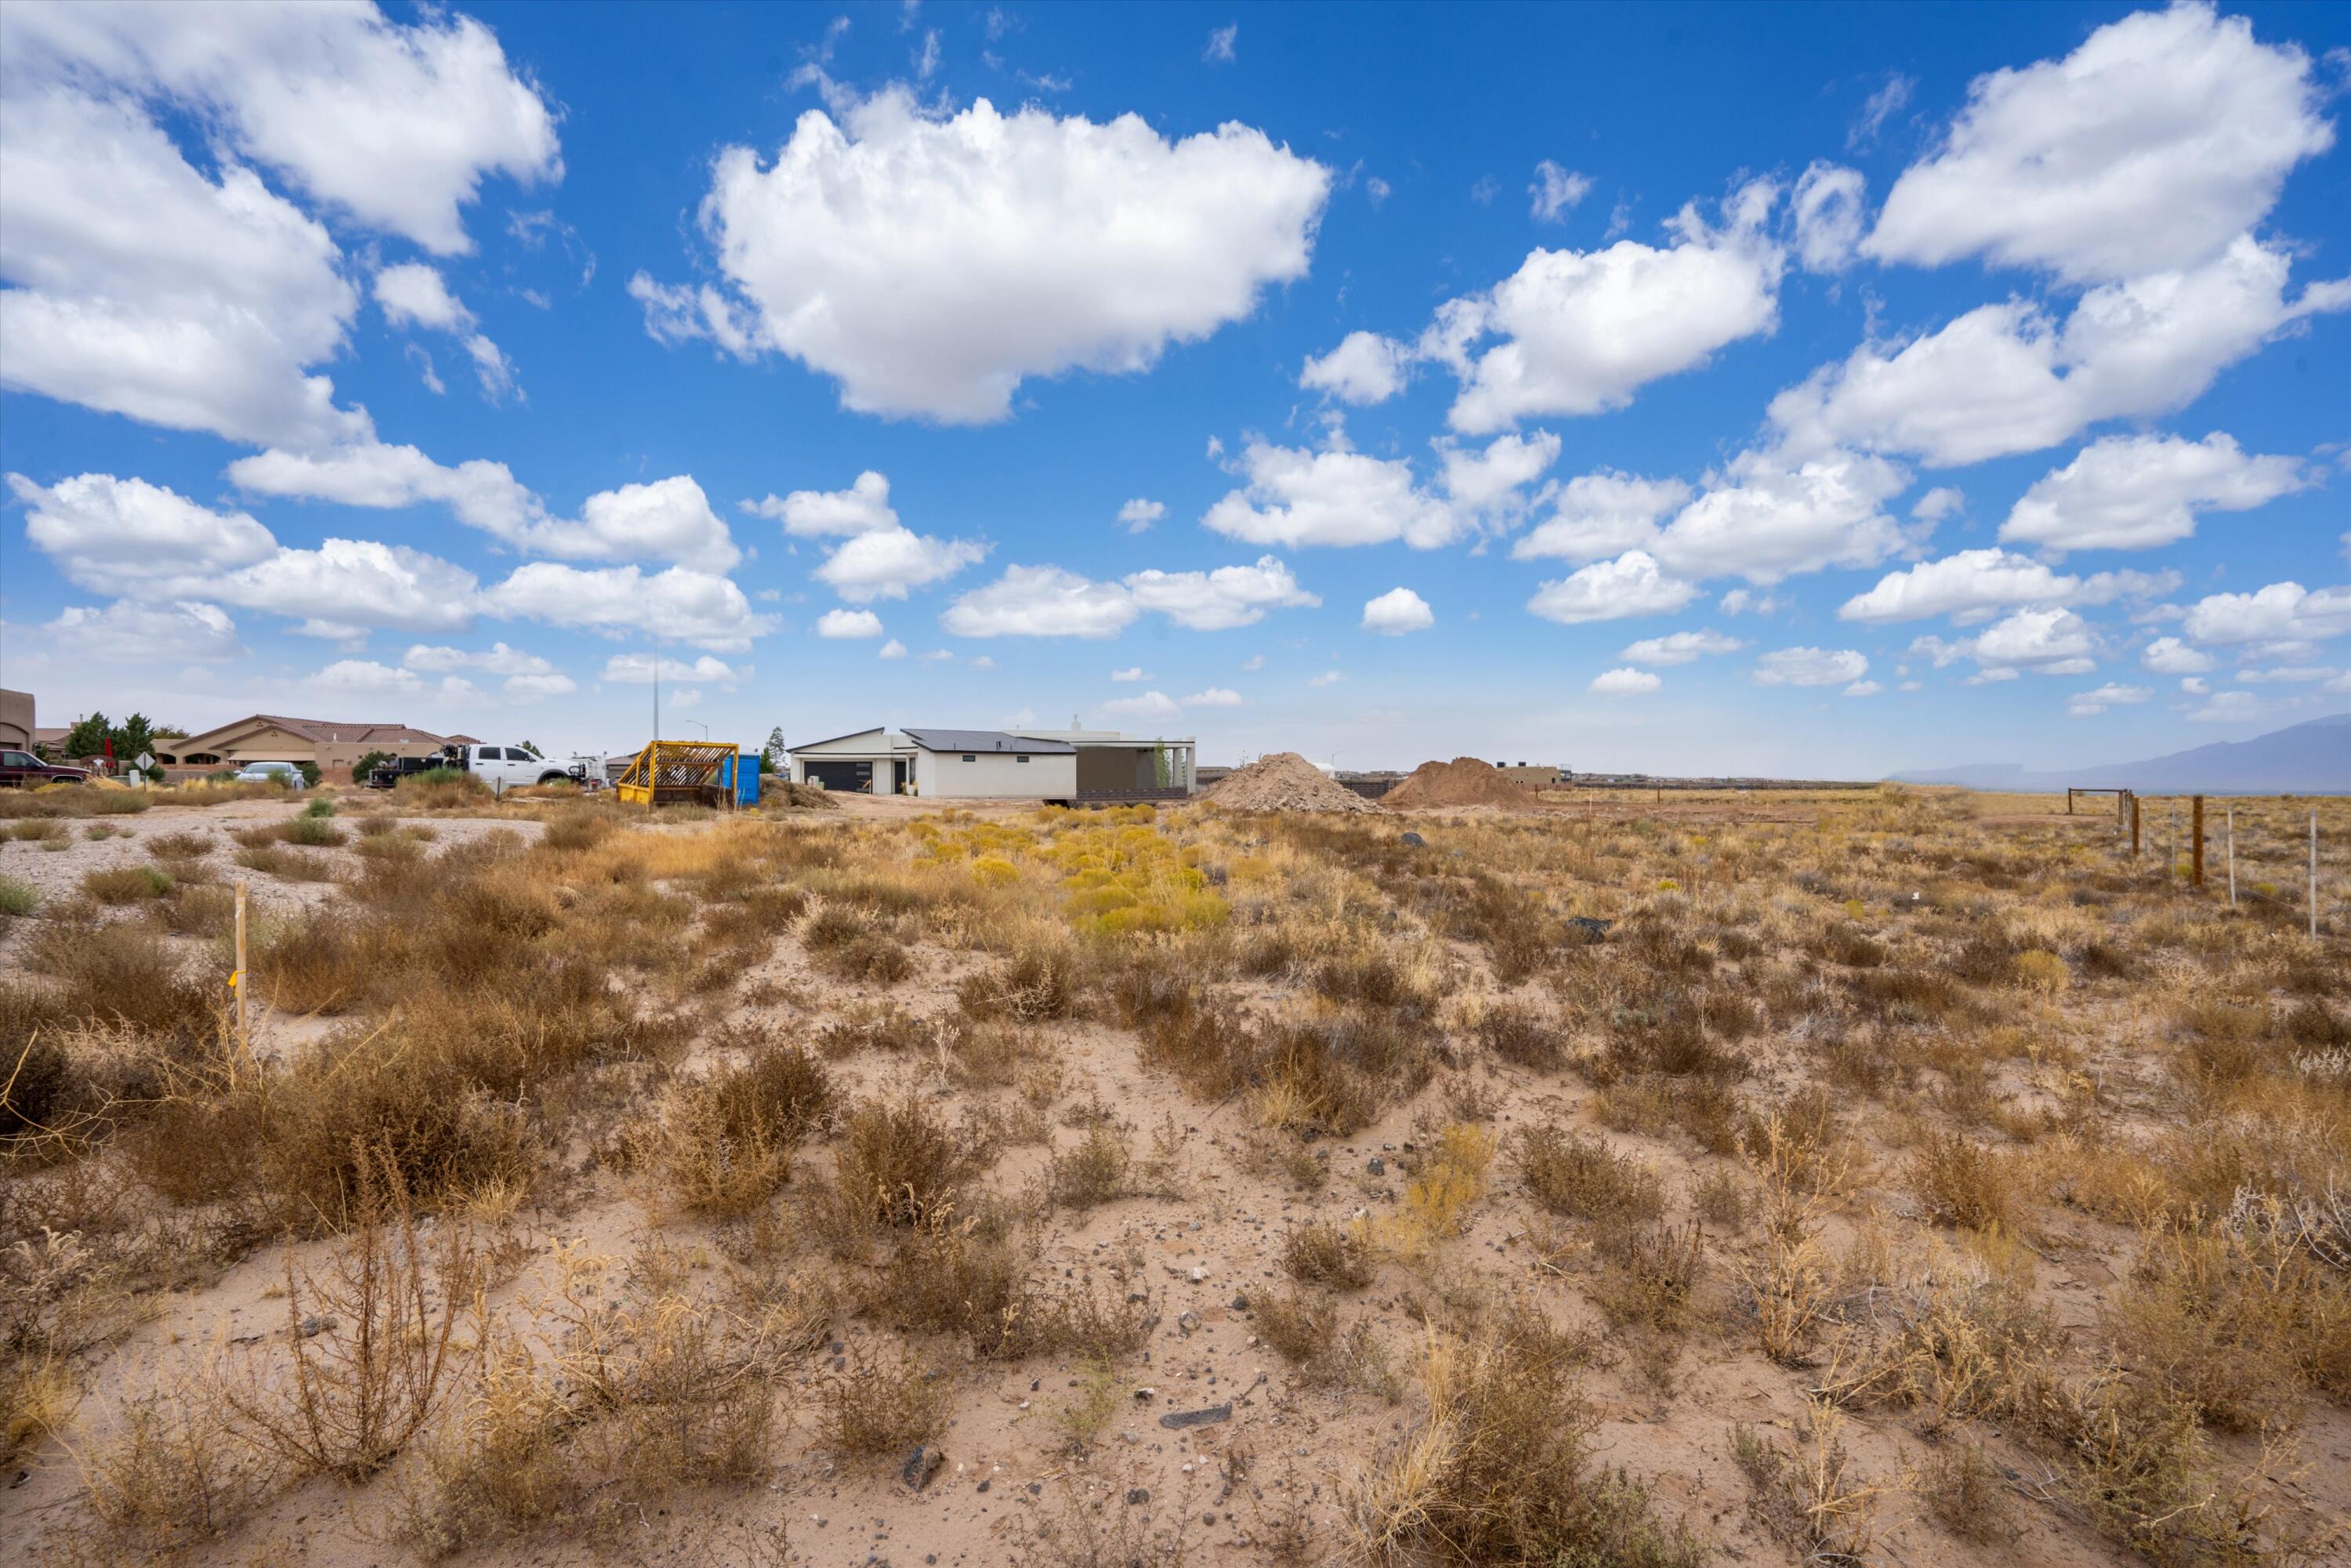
left=0, top=797, right=2351, bottom=1568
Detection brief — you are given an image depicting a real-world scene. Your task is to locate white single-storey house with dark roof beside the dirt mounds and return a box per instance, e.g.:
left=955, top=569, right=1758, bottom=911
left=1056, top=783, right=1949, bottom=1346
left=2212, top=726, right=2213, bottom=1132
left=785, top=726, right=1197, bottom=804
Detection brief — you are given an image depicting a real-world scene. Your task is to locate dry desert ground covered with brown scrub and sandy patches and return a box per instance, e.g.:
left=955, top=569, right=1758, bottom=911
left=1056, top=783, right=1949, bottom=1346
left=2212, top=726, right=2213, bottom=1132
left=0, top=783, right=2351, bottom=1568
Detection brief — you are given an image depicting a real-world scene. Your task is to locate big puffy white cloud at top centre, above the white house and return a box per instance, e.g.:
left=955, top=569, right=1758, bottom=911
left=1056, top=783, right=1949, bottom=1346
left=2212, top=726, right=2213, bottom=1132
left=632, top=87, right=1331, bottom=423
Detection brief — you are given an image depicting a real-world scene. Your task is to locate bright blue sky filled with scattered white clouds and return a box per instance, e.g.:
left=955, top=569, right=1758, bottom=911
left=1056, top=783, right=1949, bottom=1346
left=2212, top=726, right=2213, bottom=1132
left=0, top=0, right=2351, bottom=776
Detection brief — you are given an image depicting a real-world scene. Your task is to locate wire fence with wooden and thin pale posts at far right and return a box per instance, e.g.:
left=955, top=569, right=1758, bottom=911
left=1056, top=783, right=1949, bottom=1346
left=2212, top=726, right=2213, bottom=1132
left=2076, top=792, right=2351, bottom=938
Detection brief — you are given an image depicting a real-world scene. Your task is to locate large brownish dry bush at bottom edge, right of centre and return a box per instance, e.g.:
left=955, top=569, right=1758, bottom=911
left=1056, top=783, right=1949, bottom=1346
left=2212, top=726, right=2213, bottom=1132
left=1342, top=1312, right=1707, bottom=1568
